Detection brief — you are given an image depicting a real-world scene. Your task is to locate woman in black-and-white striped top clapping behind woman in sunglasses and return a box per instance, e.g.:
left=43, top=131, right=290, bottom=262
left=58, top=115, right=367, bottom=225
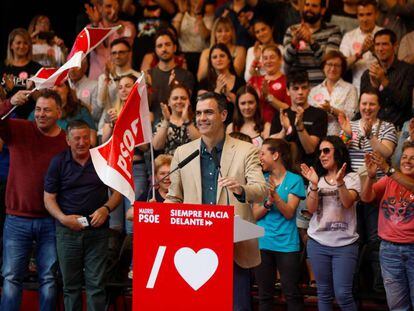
left=339, top=89, right=397, bottom=291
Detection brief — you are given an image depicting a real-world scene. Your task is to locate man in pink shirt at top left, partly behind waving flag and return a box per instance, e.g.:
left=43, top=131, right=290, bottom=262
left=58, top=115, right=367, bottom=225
left=86, top=0, right=137, bottom=80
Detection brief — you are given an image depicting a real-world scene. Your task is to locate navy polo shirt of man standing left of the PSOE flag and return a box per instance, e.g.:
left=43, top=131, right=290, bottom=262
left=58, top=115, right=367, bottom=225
left=45, top=149, right=108, bottom=216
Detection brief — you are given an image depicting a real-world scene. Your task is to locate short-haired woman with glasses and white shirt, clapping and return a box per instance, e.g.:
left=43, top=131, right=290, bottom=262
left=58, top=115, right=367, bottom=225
left=308, top=51, right=358, bottom=135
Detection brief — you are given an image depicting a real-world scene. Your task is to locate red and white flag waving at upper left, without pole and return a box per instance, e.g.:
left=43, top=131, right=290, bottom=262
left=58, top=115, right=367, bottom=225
left=29, top=26, right=119, bottom=90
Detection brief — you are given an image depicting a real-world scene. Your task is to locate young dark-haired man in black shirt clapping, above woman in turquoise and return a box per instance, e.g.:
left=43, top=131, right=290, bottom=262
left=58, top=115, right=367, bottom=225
left=270, top=71, right=328, bottom=169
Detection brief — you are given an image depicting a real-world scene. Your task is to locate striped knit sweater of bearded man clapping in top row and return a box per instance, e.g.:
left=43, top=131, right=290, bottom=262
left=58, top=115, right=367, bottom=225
left=283, top=23, right=342, bottom=86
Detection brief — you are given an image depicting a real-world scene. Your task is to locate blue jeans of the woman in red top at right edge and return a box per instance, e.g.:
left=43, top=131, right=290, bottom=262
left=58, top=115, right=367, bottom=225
left=380, top=241, right=414, bottom=311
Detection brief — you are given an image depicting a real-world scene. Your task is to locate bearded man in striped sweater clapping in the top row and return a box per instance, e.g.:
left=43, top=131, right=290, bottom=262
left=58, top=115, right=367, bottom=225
left=283, top=0, right=341, bottom=86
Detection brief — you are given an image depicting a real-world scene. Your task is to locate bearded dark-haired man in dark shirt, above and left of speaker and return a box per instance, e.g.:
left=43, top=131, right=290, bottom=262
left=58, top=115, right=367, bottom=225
left=147, top=29, right=194, bottom=124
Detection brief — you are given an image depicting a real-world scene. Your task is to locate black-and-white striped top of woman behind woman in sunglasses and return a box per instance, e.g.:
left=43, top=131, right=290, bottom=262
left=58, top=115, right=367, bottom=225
left=348, top=119, right=398, bottom=177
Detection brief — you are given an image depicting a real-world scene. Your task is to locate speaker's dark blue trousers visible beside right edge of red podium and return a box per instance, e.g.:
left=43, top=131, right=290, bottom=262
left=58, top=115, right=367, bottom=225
left=233, top=263, right=252, bottom=311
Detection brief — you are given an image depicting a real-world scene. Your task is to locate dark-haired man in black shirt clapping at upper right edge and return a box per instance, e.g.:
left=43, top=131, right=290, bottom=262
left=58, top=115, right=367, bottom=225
left=361, top=29, right=414, bottom=129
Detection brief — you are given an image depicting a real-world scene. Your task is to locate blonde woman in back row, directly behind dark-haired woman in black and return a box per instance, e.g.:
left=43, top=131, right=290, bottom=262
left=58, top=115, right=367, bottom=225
left=197, top=17, right=246, bottom=81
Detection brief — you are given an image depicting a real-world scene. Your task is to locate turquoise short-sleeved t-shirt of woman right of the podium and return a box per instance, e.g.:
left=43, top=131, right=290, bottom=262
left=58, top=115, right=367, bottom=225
left=257, top=171, right=306, bottom=253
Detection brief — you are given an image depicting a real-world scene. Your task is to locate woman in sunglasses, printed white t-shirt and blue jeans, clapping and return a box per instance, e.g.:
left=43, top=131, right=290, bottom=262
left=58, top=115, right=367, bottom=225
left=301, top=136, right=361, bottom=311
